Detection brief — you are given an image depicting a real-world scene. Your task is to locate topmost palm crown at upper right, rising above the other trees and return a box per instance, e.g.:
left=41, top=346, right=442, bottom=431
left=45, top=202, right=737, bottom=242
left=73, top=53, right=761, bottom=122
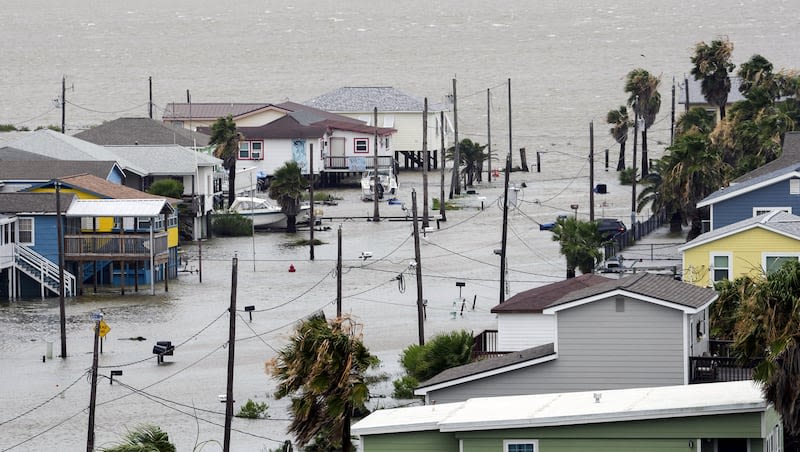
left=691, top=39, right=736, bottom=119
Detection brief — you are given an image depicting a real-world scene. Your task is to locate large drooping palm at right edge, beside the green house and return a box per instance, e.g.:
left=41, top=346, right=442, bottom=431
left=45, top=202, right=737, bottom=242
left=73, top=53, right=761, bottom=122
left=733, top=260, right=800, bottom=451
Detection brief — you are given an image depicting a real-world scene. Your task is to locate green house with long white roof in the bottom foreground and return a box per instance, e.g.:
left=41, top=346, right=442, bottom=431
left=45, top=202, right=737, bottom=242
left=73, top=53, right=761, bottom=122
left=352, top=381, right=783, bottom=452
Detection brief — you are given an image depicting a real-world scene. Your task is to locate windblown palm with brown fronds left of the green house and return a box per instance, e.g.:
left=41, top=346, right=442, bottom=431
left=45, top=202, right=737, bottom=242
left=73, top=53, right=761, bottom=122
left=267, top=314, right=379, bottom=452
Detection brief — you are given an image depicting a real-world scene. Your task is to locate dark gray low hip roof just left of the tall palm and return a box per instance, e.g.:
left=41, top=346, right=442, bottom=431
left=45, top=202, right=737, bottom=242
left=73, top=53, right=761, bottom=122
left=74, top=118, right=210, bottom=147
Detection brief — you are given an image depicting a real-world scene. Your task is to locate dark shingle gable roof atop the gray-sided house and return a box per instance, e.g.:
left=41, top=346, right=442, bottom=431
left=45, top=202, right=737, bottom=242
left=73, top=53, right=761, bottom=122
left=548, top=272, right=717, bottom=310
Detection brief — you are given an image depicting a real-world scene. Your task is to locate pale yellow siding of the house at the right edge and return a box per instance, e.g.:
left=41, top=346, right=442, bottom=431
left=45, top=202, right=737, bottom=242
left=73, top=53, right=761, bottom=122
left=683, top=228, right=800, bottom=287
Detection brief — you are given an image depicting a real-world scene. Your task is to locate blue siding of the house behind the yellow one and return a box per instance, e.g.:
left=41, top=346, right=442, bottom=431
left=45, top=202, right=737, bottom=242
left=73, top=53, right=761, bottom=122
left=713, top=179, right=800, bottom=229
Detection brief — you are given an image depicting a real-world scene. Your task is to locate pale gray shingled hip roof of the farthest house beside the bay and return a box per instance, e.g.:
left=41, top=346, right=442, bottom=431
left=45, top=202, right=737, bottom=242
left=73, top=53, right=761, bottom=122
left=303, top=86, right=442, bottom=113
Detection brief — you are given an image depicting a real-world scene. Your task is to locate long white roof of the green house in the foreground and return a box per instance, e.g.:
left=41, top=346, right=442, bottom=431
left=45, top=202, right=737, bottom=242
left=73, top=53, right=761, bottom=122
left=352, top=381, right=769, bottom=435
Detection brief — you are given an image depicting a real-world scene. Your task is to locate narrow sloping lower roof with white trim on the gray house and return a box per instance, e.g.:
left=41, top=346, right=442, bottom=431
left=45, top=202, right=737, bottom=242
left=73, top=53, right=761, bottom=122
left=414, top=343, right=557, bottom=395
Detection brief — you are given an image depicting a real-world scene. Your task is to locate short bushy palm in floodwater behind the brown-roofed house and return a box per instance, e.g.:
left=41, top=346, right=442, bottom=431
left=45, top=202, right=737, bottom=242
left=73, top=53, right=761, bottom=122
left=553, top=217, right=603, bottom=278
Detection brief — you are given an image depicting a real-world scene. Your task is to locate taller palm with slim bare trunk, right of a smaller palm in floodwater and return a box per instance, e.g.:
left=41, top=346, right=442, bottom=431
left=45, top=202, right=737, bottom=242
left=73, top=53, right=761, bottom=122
left=625, top=68, right=661, bottom=177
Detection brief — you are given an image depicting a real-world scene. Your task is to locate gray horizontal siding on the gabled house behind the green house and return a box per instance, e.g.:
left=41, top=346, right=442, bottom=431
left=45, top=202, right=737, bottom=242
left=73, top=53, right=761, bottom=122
left=428, top=298, right=687, bottom=403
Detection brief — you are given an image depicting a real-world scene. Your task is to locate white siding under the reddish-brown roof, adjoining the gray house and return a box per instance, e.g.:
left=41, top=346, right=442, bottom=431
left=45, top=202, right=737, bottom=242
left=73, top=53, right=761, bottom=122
left=497, top=313, right=556, bottom=352
